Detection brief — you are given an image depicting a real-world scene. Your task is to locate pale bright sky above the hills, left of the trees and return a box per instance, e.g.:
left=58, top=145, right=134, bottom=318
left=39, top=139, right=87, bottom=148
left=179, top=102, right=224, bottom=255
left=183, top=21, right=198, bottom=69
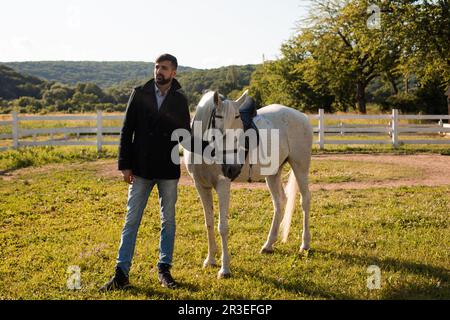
left=0, top=0, right=308, bottom=69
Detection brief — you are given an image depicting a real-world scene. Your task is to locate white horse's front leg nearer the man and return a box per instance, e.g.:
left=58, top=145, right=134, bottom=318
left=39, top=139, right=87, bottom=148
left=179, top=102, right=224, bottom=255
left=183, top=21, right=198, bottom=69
left=196, top=185, right=217, bottom=267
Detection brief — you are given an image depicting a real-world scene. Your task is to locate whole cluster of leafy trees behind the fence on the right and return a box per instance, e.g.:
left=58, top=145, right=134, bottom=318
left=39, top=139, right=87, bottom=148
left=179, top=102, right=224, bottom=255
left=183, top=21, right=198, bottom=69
left=251, top=0, right=450, bottom=113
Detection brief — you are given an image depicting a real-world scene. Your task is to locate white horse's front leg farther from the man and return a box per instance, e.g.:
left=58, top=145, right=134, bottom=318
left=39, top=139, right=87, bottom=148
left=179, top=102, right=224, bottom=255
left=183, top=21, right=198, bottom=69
left=216, top=180, right=231, bottom=279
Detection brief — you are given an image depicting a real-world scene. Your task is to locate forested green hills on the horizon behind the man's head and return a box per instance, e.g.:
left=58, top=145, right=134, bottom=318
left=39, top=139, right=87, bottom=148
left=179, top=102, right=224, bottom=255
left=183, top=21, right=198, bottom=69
left=0, top=62, right=256, bottom=113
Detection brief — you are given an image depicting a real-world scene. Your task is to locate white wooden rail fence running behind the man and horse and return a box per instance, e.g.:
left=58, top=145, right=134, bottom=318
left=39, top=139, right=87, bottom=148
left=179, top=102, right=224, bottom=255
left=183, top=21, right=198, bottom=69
left=0, top=109, right=450, bottom=152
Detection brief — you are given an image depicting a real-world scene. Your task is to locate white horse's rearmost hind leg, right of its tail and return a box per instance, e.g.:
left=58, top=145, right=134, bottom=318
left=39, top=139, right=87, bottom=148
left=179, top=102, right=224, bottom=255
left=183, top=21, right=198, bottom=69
left=289, top=160, right=311, bottom=251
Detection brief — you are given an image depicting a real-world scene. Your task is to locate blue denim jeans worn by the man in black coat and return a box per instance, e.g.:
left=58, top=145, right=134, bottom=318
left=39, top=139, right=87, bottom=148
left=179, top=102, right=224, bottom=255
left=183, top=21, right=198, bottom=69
left=117, top=176, right=178, bottom=276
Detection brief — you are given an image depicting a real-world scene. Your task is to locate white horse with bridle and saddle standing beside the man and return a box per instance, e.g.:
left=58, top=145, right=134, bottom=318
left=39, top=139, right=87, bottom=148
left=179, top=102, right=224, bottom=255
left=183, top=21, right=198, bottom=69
left=184, top=91, right=313, bottom=278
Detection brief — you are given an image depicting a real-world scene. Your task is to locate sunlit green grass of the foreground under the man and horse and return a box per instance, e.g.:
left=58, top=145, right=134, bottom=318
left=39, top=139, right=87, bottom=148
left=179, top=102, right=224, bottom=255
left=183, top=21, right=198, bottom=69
left=0, top=163, right=450, bottom=299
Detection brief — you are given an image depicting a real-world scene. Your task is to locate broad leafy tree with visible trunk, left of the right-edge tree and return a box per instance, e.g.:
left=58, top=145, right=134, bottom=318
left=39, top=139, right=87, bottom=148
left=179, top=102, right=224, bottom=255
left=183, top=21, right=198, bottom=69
left=297, top=0, right=400, bottom=113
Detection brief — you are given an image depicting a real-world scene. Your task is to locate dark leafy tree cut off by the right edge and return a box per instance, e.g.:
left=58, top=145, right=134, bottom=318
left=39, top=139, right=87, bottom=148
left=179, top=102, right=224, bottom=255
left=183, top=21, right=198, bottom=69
left=392, top=0, right=450, bottom=115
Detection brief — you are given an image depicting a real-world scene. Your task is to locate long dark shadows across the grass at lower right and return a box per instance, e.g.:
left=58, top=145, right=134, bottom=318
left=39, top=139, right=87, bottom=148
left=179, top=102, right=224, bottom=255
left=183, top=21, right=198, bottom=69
left=230, top=249, right=450, bottom=300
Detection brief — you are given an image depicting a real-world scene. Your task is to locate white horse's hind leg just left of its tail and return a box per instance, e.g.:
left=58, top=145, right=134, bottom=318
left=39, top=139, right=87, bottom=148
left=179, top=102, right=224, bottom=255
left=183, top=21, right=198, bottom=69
left=261, top=168, right=286, bottom=253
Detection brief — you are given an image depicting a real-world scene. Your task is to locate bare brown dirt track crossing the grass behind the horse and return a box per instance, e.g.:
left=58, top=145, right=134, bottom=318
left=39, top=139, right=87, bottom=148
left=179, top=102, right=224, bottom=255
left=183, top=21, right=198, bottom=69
left=0, top=154, right=450, bottom=191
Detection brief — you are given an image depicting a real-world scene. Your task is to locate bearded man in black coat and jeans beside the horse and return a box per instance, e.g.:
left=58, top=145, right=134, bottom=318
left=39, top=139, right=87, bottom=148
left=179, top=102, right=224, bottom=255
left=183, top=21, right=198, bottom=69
left=100, top=54, right=190, bottom=291
